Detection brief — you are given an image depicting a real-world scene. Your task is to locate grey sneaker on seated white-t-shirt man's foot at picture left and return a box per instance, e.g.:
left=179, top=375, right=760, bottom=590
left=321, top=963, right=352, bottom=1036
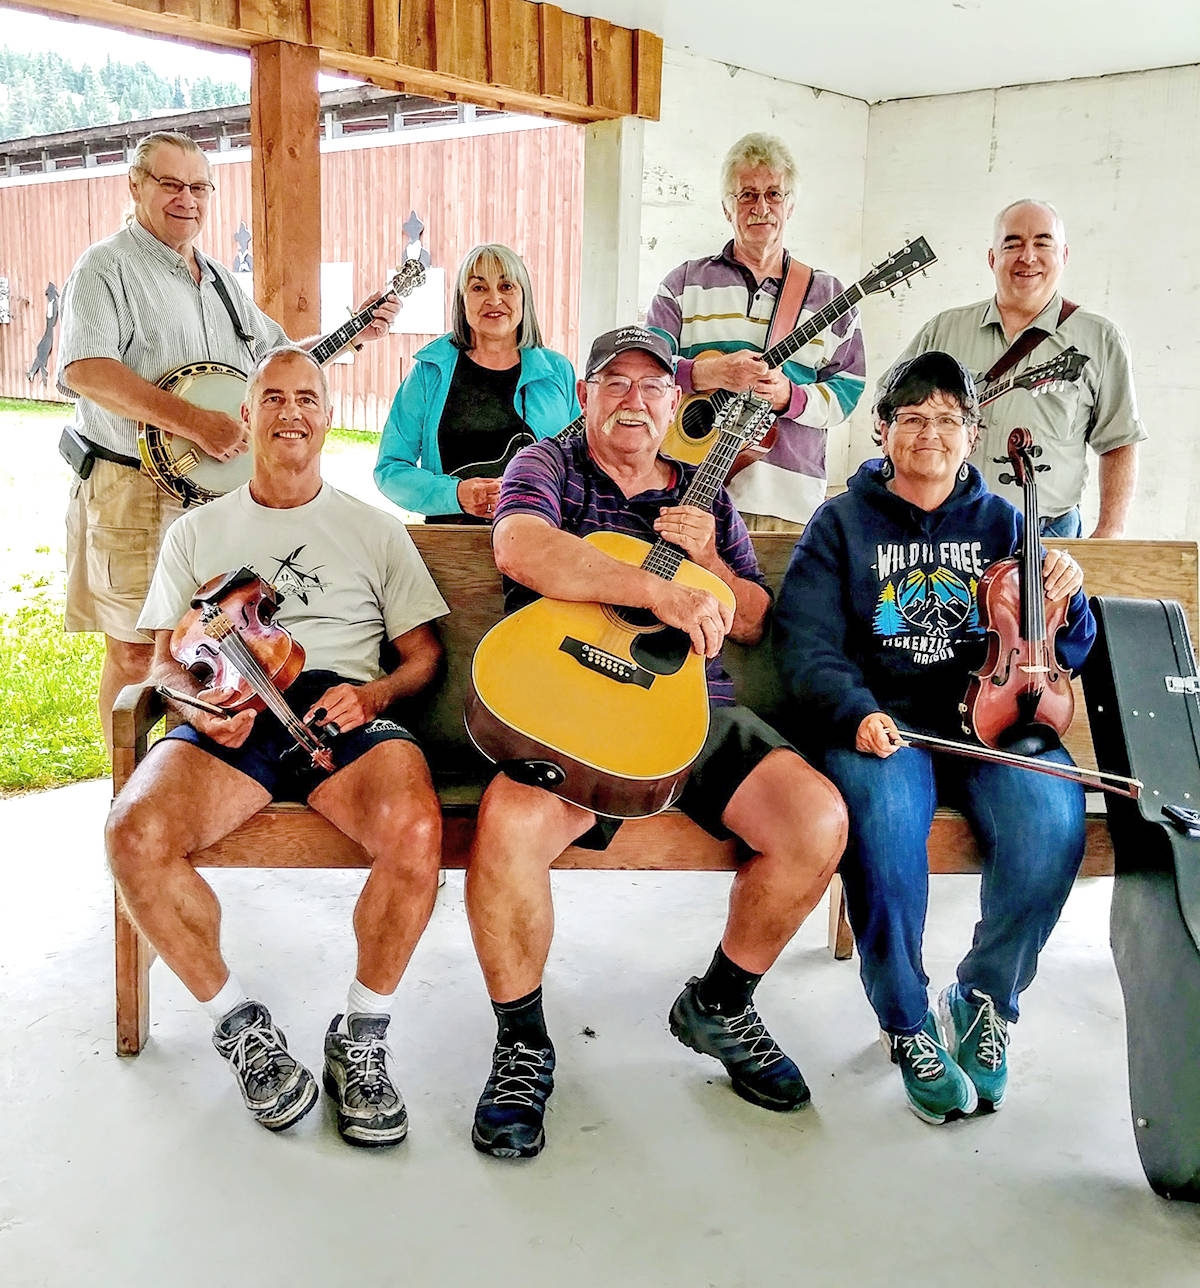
left=212, top=1002, right=317, bottom=1131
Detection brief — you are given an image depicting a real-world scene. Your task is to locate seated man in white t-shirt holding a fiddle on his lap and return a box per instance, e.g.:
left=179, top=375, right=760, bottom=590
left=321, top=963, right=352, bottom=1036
left=107, top=348, right=448, bottom=1145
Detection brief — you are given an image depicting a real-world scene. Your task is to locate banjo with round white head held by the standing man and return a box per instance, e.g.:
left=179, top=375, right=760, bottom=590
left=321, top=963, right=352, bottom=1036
left=138, top=259, right=425, bottom=506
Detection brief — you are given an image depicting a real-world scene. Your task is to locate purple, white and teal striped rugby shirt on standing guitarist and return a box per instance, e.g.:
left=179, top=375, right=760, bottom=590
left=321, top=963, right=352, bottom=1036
left=646, top=241, right=867, bottom=523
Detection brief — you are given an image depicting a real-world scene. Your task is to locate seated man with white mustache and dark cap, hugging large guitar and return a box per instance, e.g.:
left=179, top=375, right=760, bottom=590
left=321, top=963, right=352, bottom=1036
left=466, top=326, right=846, bottom=1158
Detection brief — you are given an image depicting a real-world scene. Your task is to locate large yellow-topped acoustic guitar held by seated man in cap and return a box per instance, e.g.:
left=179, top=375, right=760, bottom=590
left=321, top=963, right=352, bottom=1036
left=466, top=394, right=770, bottom=818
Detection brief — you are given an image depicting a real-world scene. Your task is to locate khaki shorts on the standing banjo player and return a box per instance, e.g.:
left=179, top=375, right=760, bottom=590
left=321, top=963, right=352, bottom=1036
left=64, top=461, right=183, bottom=644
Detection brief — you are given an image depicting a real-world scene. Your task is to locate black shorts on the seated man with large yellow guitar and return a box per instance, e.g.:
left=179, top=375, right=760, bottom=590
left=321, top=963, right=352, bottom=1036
left=574, top=706, right=800, bottom=850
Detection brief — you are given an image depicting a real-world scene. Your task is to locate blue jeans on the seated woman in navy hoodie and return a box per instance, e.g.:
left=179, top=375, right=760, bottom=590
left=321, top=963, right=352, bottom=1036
left=824, top=747, right=1084, bottom=1033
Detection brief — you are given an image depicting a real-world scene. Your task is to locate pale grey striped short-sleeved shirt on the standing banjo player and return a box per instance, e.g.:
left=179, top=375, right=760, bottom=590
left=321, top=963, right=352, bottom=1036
left=57, top=219, right=290, bottom=457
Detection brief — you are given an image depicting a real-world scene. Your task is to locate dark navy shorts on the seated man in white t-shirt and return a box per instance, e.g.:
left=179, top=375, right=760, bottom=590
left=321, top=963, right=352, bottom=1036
left=162, top=671, right=416, bottom=801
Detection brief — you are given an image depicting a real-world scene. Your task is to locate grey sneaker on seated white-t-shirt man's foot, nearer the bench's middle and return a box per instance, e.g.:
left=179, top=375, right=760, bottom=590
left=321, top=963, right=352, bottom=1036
left=323, top=1011, right=408, bottom=1146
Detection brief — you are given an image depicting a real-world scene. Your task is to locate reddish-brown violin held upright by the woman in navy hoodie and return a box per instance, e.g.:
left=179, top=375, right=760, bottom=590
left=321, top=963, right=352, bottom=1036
left=959, top=429, right=1075, bottom=756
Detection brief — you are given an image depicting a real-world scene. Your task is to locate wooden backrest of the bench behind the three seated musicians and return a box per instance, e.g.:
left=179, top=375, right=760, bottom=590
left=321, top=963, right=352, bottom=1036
left=409, top=524, right=1200, bottom=777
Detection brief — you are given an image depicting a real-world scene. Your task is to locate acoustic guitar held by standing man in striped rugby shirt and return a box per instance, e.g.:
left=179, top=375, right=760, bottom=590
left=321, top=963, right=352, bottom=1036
left=662, top=237, right=937, bottom=473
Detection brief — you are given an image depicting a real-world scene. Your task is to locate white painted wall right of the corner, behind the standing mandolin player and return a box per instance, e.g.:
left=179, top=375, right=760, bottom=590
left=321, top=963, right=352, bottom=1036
left=850, top=67, right=1200, bottom=540
